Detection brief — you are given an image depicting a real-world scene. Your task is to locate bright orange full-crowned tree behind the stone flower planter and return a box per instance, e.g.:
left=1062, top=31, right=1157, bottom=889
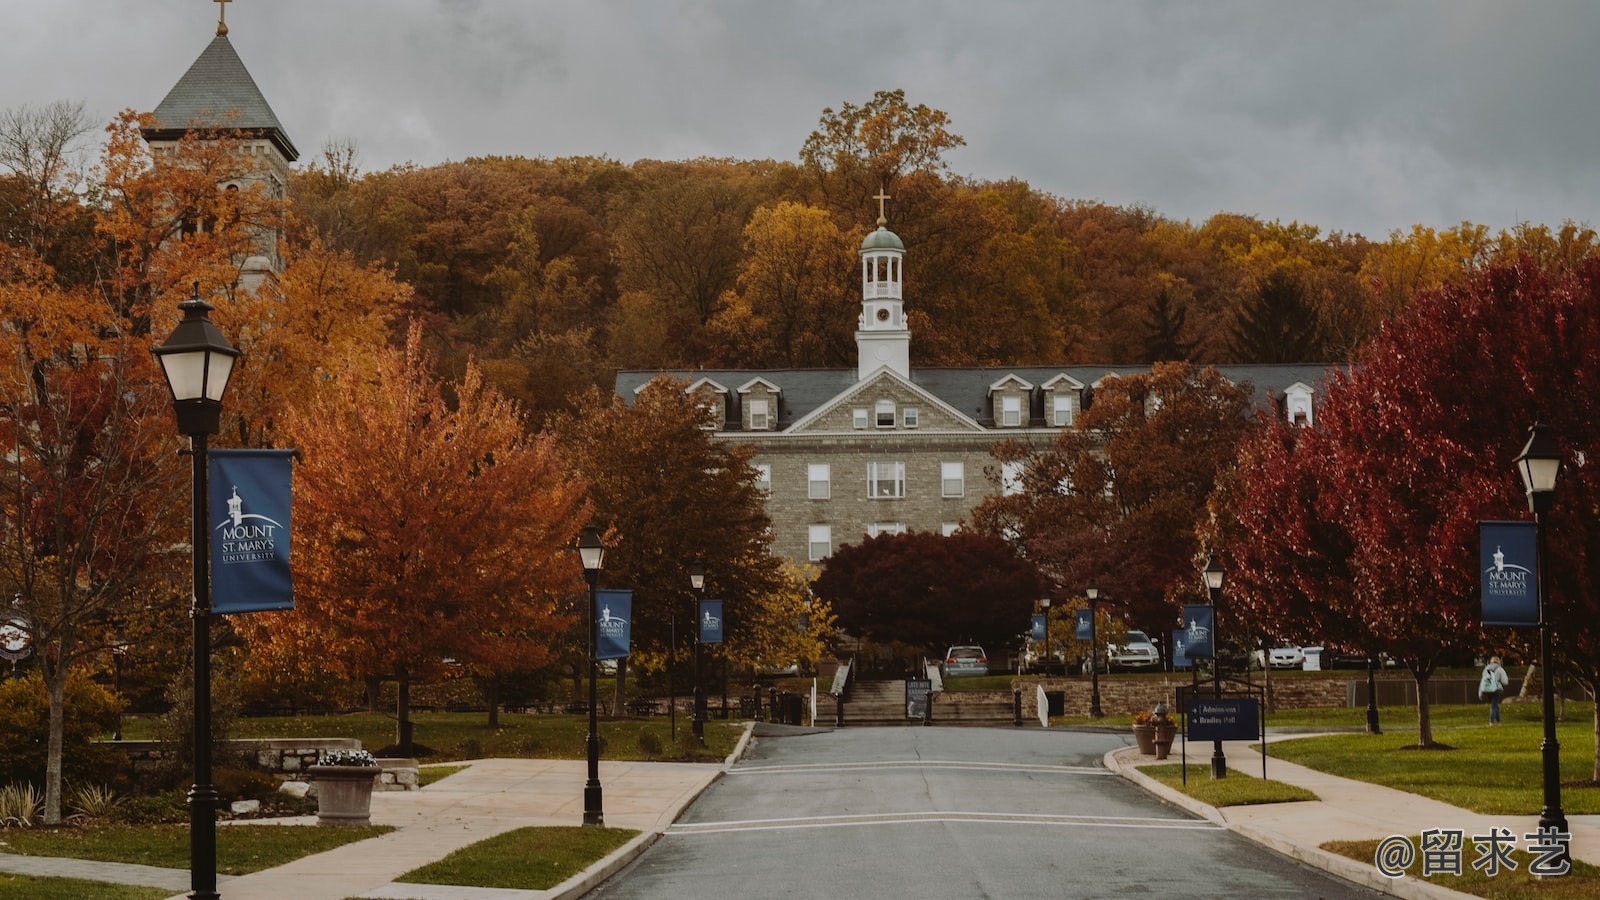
left=238, top=325, right=586, bottom=756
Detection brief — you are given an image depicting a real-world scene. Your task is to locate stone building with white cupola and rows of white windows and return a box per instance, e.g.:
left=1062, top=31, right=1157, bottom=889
left=616, top=215, right=1325, bottom=562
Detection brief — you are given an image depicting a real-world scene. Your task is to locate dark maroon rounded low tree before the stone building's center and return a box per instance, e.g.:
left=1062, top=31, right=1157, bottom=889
left=816, top=532, right=1043, bottom=653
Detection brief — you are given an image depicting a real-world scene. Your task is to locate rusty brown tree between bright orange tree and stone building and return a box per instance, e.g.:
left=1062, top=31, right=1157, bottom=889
left=550, top=378, right=830, bottom=688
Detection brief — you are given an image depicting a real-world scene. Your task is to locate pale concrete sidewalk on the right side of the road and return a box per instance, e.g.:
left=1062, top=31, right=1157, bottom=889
left=1106, top=735, right=1600, bottom=900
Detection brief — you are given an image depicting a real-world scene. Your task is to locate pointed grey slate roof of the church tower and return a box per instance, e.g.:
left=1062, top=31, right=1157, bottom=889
left=144, top=34, right=299, bottom=162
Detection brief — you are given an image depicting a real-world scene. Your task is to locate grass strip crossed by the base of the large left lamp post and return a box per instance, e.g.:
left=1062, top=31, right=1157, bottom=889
left=0, top=825, right=394, bottom=874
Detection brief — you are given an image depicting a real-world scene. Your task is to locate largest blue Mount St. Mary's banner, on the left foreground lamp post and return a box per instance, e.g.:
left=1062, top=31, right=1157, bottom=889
left=206, top=450, right=294, bottom=615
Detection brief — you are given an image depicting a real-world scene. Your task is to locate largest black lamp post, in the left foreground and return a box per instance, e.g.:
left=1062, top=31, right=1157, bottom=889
left=152, top=282, right=238, bottom=900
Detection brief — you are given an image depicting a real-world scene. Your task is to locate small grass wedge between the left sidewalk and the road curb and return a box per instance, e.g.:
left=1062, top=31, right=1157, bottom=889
left=395, top=826, right=638, bottom=890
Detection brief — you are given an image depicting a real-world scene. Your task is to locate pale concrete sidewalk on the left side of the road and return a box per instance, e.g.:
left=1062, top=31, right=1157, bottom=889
left=0, top=749, right=732, bottom=900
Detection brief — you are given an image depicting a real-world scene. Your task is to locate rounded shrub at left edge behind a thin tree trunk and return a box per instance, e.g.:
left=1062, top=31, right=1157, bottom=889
left=0, top=673, right=118, bottom=786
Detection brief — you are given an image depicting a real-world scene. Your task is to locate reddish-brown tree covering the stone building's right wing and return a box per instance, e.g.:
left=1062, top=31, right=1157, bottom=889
left=973, top=362, right=1253, bottom=634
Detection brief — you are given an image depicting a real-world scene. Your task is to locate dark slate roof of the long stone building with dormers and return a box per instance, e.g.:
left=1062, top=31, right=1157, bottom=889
left=616, top=364, right=1344, bottom=428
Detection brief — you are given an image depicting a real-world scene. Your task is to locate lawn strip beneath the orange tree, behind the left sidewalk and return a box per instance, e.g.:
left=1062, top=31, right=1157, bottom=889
left=123, top=713, right=739, bottom=762
